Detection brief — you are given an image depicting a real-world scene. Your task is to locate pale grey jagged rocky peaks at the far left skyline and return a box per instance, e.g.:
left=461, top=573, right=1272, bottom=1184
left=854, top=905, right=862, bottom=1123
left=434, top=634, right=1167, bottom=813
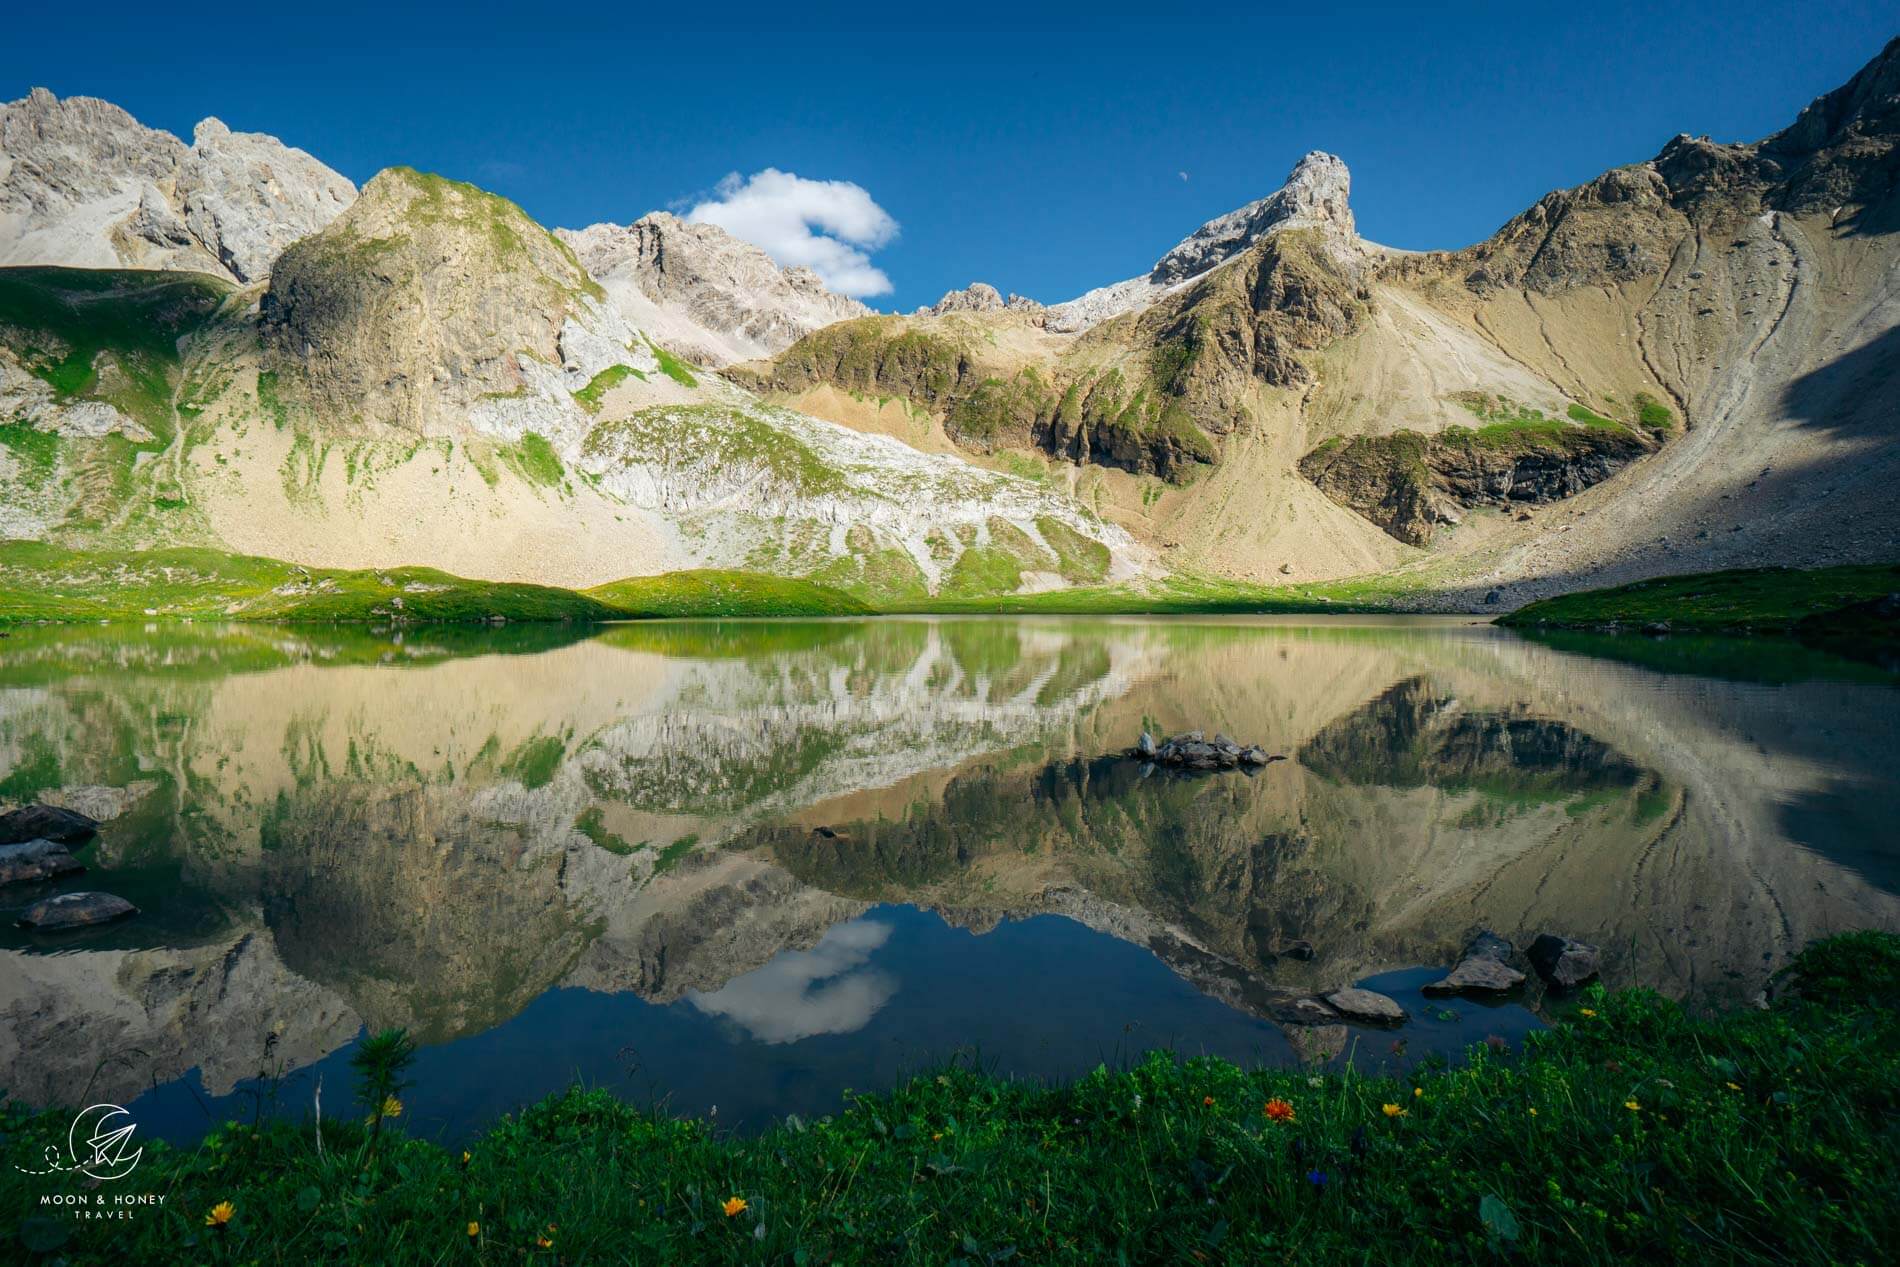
left=0, top=87, right=355, bottom=283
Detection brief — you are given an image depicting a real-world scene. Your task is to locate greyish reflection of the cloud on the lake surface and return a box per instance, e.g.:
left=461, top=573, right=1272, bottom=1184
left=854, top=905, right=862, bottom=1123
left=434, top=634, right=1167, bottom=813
left=686, top=919, right=897, bottom=1043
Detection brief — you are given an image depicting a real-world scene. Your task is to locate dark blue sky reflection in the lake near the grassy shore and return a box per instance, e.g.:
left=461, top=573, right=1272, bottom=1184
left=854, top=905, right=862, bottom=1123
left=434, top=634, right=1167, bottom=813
left=127, top=906, right=1537, bottom=1144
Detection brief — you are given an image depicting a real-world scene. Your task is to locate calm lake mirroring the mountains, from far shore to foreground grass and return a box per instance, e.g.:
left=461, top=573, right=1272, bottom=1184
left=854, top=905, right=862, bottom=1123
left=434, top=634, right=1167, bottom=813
left=0, top=619, right=1900, bottom=1140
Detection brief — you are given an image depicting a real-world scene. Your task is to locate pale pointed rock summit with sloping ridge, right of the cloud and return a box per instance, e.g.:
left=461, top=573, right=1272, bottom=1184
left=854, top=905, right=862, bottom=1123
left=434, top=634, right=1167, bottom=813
left=1047, top=150, right=1359, bottom=332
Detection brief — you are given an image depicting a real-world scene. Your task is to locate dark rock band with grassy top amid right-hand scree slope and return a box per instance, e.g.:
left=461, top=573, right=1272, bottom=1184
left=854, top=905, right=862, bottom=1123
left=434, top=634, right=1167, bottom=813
left=1300, top=420, right=1657, bottom=545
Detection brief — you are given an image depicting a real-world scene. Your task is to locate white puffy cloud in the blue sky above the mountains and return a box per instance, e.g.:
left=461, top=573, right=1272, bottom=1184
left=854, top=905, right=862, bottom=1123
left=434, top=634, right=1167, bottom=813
left=686, top=167, right=897, bottom=298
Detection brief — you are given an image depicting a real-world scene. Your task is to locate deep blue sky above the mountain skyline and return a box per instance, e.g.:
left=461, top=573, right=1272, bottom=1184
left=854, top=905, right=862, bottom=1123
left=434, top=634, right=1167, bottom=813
left=0, top=0, right=1900, bottom=308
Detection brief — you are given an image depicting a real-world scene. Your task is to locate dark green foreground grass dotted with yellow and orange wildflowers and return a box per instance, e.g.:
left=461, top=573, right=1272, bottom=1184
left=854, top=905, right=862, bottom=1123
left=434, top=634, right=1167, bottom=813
left=0, top=933, right=1900, bottom=1265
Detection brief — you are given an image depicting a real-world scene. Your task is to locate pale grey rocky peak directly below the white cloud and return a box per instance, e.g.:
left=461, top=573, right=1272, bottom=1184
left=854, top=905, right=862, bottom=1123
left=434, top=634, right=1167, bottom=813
left=557, top=211, right=870, bottom=367
